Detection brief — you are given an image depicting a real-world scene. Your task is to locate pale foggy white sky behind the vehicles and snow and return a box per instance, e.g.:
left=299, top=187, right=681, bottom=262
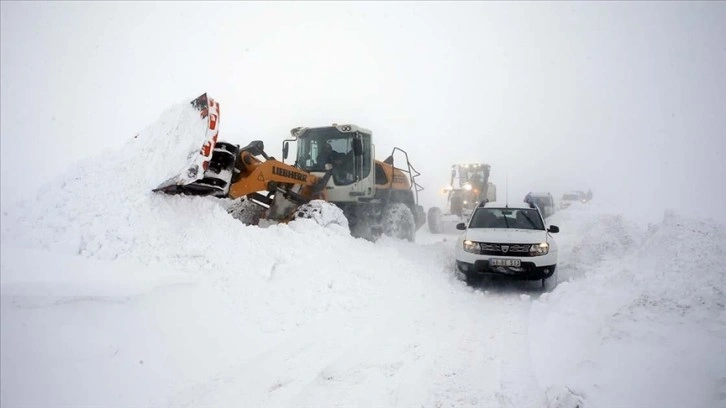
left=0, top=1, right=726, bottom=222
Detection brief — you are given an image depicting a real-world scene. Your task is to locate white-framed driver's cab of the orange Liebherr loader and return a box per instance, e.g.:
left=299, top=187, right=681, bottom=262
left=283, top=124, right=375, bottom=201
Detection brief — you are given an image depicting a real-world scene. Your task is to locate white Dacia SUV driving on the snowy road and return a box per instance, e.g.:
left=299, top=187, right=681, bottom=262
left=456, top=203, right=560, bottom=287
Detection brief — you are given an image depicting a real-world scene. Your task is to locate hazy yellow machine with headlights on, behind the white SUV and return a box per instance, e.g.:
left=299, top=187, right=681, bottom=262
left=427, top=163, right=497, bottom=234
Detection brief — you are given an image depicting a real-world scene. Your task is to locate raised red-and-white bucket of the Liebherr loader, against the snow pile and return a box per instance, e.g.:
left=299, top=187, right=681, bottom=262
left=153, top=93, right=223, bottom=195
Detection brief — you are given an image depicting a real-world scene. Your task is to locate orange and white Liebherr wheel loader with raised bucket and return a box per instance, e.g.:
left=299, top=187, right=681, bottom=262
left=153, top=94, right=426, bottom=241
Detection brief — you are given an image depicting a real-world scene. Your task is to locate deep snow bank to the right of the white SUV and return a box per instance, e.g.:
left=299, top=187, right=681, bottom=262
left=530, top=207, right=726, bottom=407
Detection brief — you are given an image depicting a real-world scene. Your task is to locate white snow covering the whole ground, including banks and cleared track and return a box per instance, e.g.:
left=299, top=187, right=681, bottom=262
left=0, top=96, right=726, bottom=408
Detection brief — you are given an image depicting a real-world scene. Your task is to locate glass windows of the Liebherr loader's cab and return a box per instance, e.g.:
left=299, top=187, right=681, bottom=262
left=297, top=127, right=371, bottom=185
